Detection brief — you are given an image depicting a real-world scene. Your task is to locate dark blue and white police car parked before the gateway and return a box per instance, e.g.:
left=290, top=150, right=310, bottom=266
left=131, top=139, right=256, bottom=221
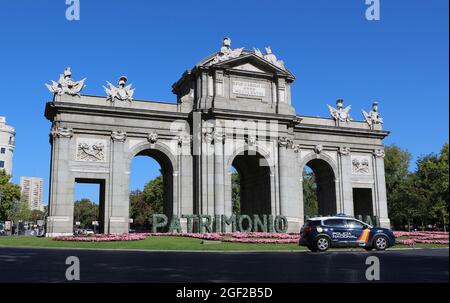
left=299, top=215, right=395, bottom=251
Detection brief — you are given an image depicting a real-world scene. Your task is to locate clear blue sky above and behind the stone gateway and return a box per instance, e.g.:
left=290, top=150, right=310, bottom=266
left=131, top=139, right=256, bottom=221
left=0, top=0, right=449, bottom=203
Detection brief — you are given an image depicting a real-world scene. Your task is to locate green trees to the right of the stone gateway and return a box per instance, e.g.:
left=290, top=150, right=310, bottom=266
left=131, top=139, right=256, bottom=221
left=384, top=144, right=449, bottom=229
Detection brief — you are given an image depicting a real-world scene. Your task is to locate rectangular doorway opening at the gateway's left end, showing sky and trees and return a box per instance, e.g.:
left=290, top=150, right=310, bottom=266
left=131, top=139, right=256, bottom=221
left=73, top=178, right=105, bottom=233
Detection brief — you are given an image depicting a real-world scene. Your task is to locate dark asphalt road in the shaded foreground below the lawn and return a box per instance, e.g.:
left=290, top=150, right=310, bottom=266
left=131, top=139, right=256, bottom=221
left=0, top=247, right=449, bottom=283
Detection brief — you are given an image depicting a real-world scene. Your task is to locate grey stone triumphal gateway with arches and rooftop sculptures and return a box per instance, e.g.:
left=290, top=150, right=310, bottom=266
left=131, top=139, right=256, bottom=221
left=45, top=38, right=389, bottom=236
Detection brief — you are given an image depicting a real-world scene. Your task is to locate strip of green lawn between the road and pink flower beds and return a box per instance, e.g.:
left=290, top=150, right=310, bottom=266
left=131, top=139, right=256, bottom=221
left=0, top=236, right=448, bottom=251
